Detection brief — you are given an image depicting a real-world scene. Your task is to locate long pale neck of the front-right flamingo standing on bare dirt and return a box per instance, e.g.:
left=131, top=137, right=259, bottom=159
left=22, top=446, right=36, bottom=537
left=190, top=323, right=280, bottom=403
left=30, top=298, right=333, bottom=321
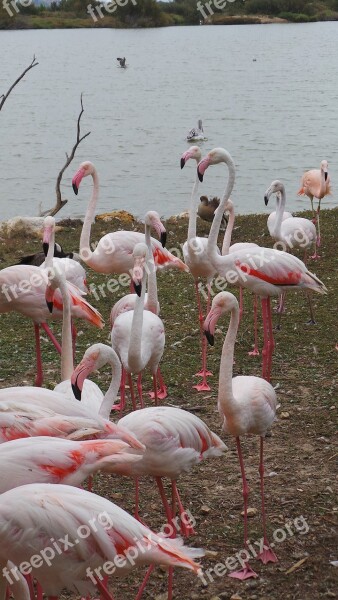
left=218, top=306, right=239, bottom=415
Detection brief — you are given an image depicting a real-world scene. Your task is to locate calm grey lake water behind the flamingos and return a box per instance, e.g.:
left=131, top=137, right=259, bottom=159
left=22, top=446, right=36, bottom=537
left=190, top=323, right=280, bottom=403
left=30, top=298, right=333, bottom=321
left=0, top=22, right=338, bottom=220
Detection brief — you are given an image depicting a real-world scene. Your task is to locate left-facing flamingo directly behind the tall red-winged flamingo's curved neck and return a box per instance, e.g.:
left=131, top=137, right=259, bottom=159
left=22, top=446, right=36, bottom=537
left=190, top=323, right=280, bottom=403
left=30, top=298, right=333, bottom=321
left=181, top=146, right=216, bottom=392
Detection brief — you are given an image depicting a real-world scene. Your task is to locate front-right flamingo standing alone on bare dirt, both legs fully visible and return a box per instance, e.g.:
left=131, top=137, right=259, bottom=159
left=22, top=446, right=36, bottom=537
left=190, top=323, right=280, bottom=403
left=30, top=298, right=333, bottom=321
left=204, top=292, right=277, bottom=580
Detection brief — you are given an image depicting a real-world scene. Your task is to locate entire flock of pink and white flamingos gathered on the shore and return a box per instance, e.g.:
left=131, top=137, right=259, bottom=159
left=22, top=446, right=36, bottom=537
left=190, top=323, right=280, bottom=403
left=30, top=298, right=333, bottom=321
left=0, top=146, right=330, bottom=600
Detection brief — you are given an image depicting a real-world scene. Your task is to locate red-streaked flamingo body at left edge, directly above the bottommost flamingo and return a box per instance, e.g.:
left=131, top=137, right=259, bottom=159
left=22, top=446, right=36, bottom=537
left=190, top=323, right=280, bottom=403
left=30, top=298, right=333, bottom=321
left=0, top=436, right=141, bottom=494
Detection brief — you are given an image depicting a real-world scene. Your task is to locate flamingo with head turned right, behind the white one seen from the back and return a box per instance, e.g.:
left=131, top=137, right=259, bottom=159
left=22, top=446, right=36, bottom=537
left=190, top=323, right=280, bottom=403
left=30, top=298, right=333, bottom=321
left=110, top=210, right=168, bottom=400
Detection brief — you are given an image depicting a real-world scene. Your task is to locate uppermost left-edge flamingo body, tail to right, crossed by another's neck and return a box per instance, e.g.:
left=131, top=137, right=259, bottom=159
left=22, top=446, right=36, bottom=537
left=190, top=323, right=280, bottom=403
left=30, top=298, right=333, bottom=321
left=0, top=265, right=103, bottom=386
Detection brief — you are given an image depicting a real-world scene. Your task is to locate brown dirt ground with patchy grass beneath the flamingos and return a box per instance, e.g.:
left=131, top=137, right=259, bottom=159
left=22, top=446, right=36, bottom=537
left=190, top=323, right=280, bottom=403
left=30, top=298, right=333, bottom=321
left=0, top=209, right=338, bottom=600
